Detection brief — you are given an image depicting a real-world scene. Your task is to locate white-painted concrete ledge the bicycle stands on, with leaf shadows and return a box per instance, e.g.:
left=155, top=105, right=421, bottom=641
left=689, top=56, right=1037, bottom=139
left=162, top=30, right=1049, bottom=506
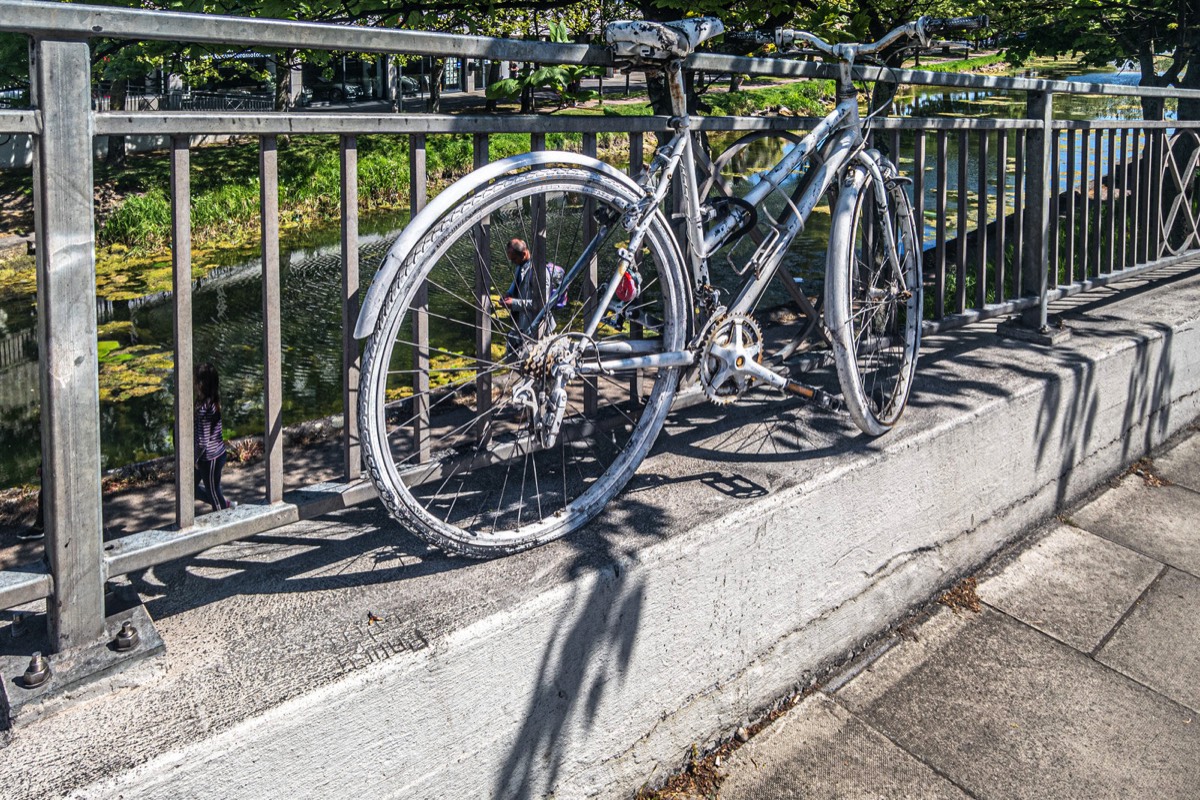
left=0, top=262, right=1200, bottom=799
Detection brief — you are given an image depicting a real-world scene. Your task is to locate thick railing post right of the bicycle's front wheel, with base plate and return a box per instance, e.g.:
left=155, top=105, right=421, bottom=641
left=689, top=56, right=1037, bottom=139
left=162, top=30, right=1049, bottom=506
left=1006, top=91, right=1058, bottom=343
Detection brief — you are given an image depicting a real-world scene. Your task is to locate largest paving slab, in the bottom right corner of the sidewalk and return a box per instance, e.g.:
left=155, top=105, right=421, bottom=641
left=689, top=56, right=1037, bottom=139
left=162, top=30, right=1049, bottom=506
left=838, top=608, right=1200, bottom=800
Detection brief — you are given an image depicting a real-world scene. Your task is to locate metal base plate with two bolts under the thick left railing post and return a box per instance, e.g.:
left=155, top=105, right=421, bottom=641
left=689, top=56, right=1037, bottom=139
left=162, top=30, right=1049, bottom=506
left=0, top=591, right=166, bottom=730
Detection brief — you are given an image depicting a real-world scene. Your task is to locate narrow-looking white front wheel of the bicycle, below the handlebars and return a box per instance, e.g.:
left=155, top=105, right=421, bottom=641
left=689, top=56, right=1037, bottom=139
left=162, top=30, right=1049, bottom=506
left=826, top=162, right=922, bottom=437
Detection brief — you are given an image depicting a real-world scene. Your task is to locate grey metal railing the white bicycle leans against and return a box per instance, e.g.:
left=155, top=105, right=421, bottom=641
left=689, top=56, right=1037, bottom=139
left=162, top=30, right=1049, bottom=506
left=0, top=0, right=1200, bottom=690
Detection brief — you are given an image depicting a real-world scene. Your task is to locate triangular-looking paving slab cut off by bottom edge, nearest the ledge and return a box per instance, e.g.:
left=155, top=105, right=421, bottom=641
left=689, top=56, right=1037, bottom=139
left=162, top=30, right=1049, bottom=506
left=720, top=693, right=968, bottom=800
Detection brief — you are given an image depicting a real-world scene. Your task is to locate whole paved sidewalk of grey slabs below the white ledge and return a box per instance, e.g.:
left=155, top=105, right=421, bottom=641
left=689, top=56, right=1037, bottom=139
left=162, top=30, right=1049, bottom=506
left=720, top=425, right=1200, bottom=800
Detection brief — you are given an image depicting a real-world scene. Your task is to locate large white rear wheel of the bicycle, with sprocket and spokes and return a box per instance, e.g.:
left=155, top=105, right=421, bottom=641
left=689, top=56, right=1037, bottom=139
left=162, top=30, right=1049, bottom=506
left=359, top=167, right=688, bottom=558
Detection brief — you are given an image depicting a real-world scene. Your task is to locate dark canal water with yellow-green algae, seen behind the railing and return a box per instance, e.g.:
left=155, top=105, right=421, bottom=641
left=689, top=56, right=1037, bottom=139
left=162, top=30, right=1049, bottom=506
left=0, top=64, right=1171, bottom=487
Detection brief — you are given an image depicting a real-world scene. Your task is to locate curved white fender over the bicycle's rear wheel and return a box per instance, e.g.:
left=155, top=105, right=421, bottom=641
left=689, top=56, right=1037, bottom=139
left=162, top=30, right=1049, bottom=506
left=354, top=150, right=642, bottom=339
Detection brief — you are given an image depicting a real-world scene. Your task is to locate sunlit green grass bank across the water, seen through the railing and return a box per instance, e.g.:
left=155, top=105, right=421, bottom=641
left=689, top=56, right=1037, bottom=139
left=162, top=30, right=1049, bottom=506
left=77, top=82, right=832, bottom=257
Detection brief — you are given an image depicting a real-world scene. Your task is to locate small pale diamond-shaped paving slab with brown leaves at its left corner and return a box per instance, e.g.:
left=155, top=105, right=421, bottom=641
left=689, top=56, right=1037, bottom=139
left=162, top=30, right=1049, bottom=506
left=979, top=523, right=1163, bottom=652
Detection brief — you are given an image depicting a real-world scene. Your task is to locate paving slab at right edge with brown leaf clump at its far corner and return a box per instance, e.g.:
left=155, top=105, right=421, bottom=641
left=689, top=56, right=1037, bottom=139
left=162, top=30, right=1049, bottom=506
left=1070, top=475, right=1200, bottom=576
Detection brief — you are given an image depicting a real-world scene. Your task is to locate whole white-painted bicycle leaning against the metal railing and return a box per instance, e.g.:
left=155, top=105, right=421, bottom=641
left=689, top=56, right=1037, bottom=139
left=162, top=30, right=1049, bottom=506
left=355, top=12, right=985, bottom=558
